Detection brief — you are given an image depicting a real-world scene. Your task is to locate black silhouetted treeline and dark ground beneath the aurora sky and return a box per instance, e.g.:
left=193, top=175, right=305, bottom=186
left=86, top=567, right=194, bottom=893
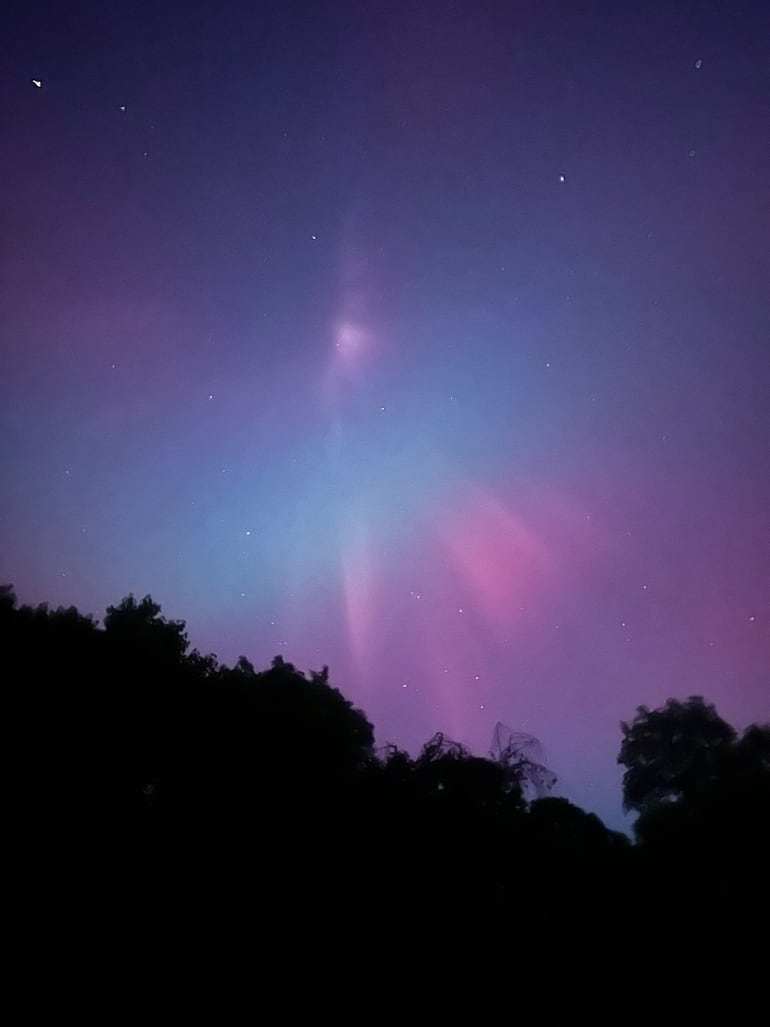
left=0, top=586, right=770, bottom=1024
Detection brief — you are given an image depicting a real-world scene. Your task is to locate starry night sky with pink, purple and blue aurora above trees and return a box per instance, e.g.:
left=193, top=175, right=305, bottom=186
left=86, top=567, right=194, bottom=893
left=0, top=0, right=770, bottom=826
